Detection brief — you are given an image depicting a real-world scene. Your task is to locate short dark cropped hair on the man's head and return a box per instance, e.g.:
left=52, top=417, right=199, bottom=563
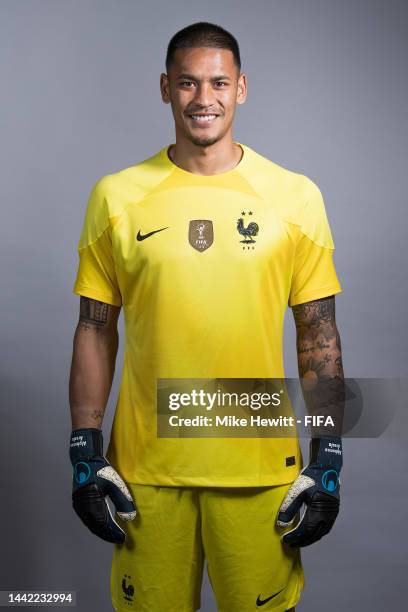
left=166, top=21, right=241, bottom=72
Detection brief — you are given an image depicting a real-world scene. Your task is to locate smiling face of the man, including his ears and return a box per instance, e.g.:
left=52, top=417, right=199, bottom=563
left=160, top=47, right=246, bottom=147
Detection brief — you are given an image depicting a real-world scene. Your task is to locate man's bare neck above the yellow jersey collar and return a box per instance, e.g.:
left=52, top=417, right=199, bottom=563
left=168, top=138, right=243, bottom=176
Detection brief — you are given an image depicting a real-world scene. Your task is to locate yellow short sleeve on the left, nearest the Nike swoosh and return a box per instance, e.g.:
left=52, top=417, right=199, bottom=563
left=73, top=177, right=122, bottom=306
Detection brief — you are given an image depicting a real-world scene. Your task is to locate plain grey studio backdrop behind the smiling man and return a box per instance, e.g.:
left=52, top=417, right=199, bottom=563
left=0, top=0, right=408, bottom=612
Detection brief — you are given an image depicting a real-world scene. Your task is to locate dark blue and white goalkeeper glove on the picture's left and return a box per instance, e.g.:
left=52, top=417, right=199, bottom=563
left=69, top=428, right=136, bottom=544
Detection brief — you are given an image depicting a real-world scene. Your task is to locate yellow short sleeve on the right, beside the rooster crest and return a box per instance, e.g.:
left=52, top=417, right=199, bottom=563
left=288, top=179, right=342, bottom=307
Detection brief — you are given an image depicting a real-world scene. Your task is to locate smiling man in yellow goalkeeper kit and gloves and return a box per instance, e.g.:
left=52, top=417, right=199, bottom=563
left=70, top=22, right=343, bottom=612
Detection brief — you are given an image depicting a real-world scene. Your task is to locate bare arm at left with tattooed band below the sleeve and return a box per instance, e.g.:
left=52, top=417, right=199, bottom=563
left=69, top=296, right=120, bottom=429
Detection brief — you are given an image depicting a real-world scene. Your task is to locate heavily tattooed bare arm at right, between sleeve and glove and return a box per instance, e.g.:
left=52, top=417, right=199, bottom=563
left=293, top=295, right=345, bottom=436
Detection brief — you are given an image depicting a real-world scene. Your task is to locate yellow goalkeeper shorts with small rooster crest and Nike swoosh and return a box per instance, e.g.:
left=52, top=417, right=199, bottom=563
left=111, top=484, right=304, bottom=612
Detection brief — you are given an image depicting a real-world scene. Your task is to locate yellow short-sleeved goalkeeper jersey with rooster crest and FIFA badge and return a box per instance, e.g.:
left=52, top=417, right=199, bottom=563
left=73, top=143, right=341, bottom=487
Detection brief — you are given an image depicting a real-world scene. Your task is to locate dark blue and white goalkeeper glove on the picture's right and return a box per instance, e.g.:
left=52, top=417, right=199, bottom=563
left=276, top=437, right=343, bottom=547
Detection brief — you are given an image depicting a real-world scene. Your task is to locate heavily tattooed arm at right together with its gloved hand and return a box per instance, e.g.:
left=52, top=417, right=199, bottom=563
left=277, top=295, right=345, bottom=548
